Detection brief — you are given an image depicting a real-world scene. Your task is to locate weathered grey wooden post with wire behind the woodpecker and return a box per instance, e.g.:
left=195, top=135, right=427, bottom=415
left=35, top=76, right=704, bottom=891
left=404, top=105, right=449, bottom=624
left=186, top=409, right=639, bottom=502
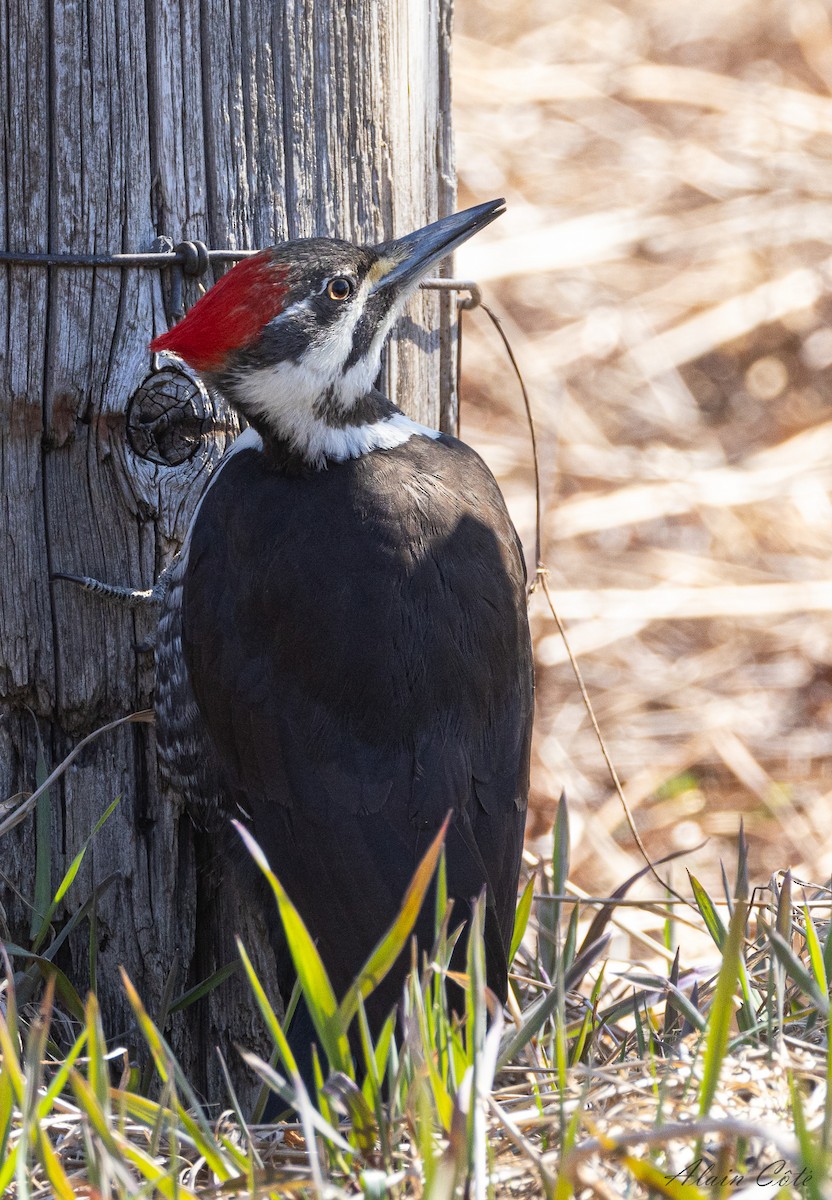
left=0, top=0, right=455, bottom=1098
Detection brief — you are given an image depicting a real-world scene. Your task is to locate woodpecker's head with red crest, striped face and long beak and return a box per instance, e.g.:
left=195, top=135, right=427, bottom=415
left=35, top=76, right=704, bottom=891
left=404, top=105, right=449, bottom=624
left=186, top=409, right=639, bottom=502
left=151, top=199, right=504, bottom=466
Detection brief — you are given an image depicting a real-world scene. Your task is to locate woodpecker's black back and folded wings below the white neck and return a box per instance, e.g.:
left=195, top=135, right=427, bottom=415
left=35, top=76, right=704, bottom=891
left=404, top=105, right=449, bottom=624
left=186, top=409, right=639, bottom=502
left=184, top=438, right=532, bottom=990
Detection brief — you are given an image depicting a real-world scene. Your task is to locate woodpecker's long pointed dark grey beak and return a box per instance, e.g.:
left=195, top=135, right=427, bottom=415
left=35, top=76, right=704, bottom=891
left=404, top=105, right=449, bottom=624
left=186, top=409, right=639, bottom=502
left=370, top=199, right=505, bottom=293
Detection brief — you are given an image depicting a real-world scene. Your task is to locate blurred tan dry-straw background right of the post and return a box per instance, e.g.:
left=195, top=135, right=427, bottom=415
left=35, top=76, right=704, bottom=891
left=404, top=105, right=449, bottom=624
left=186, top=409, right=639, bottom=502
left=453, top=0, right=832, bottom=894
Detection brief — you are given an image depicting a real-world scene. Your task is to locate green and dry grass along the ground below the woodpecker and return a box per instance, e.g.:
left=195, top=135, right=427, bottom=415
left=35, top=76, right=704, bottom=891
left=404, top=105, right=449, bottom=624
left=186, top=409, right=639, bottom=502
left=0, top=799, right=832, bottom=1200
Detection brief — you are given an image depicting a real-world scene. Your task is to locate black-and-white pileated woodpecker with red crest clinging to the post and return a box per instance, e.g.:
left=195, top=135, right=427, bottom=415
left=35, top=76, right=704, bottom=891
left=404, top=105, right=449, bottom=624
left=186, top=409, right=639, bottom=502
left=151, top=200, right=533, bottom=1075
